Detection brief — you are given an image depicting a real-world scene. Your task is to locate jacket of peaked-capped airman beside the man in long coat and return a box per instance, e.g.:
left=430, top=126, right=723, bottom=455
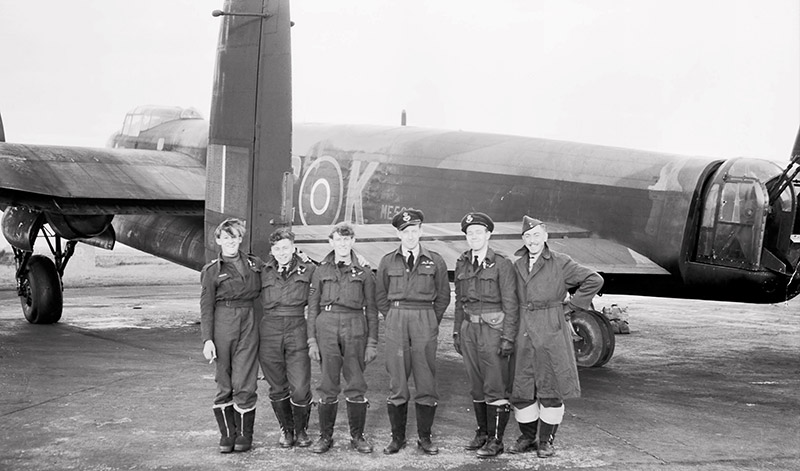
left=453, top=248, right=519, bottom=342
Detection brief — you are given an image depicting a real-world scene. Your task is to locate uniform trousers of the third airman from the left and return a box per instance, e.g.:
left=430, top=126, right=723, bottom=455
left=316, top=311, right=367, bottom=403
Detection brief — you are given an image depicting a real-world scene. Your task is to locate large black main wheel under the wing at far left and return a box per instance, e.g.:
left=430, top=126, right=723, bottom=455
left=19, top=255, right=64, bottom=324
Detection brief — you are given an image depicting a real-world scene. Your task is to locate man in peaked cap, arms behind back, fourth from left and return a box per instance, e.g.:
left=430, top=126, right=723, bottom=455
left=375, top=209, right=450, bottom=455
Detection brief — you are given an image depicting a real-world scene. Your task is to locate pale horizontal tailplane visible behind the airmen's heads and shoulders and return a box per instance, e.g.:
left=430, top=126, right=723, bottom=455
left=292, top=222, right=669, bottom=275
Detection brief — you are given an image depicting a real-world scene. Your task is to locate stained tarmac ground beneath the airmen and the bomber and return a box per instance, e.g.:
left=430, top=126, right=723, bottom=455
left=0, top=249, right=800, bottom=471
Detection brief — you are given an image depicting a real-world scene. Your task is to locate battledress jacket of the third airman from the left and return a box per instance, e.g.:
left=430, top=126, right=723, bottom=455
left=308, top=251, right=378, bottom=340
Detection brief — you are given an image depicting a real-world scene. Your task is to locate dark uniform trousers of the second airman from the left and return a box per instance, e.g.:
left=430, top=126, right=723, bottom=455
left=258, top=313, right=311, bottom=406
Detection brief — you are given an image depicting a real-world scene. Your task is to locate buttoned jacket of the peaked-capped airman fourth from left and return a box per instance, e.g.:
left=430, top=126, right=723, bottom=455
left=375, top=245, right=450, bottom=322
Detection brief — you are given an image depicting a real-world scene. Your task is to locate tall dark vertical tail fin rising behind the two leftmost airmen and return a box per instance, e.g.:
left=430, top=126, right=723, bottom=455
left=205, top=0, right=292, bottom=260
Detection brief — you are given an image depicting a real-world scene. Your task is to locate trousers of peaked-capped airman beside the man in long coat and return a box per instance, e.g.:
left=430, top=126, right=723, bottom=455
left=461, top=322, right=511, bottom=405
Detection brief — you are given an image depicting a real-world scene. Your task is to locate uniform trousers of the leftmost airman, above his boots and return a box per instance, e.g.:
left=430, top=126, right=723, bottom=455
left=213, top=306, right=258, bottom=410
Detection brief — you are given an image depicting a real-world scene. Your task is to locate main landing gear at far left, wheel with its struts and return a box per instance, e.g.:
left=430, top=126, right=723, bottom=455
left=14, top=226, right=77, bottom=324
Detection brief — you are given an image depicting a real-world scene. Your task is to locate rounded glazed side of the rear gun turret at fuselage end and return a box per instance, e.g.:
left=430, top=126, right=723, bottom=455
left=696, top=159, right=769, bottom=270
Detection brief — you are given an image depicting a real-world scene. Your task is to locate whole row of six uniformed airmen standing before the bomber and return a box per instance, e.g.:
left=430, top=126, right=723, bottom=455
left=200, top=208, right=603, bottom=458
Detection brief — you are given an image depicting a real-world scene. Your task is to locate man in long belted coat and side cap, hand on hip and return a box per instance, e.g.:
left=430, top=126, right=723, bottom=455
left=508, top=216, right=603, bottom=458
